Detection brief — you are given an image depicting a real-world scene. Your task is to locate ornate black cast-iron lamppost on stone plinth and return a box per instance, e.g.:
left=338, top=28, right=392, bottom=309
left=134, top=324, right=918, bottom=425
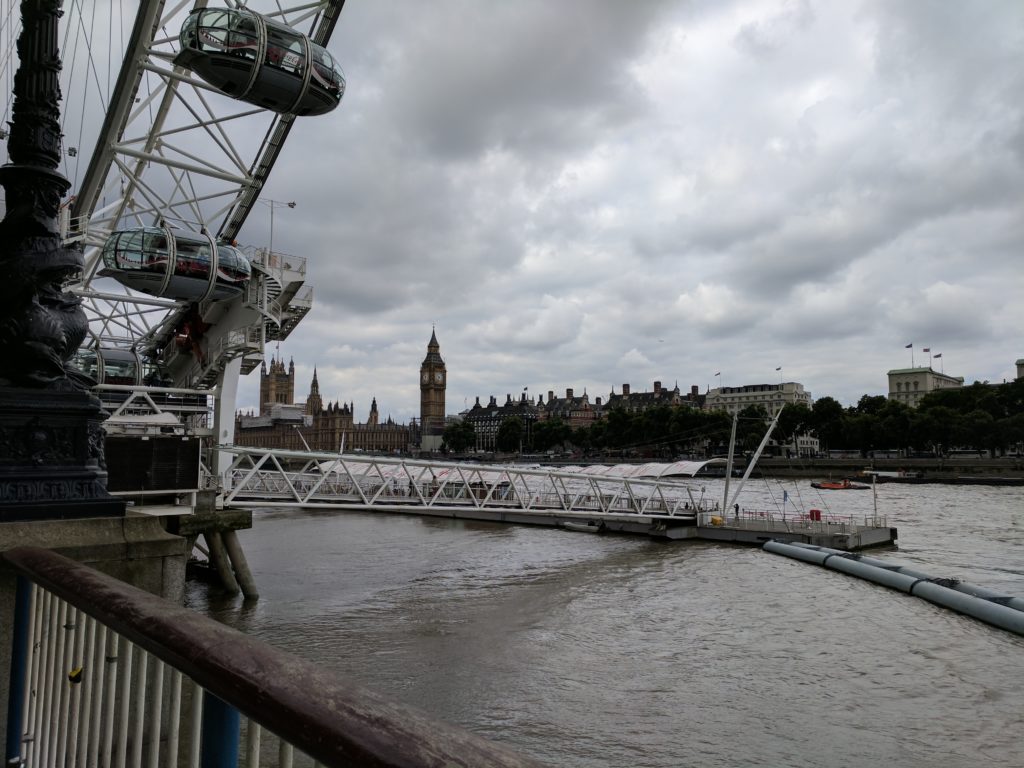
left=0, top=0, right=124, bottom=521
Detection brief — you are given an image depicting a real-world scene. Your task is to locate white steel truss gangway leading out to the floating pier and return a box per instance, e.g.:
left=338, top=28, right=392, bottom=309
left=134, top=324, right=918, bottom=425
left=218, top=445, right=709, bottom=528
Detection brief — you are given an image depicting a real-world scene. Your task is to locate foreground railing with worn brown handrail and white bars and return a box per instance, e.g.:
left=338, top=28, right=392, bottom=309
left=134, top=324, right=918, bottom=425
left=3, top=547, right=539, bottom=768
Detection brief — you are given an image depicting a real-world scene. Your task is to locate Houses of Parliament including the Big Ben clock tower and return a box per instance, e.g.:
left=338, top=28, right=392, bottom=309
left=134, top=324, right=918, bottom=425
left=234, top=332, right=447, bottom=454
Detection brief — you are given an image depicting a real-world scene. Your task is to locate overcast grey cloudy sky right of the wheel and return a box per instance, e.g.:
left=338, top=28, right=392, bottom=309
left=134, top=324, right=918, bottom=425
left=66, top=0, right=1024, bottom=422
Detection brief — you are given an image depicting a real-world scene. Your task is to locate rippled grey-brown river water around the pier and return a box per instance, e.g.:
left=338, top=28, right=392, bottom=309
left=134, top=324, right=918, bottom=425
left=187, top=480, right=1024, bottom=768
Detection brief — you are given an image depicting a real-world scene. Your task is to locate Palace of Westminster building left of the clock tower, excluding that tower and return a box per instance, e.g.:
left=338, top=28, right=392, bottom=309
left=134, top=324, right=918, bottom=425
left=234, top=359, right=412, bottom=453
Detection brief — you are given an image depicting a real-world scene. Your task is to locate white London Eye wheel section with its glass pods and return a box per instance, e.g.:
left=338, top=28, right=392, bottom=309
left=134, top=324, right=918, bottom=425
left=0, top=0, right=345, bottom=399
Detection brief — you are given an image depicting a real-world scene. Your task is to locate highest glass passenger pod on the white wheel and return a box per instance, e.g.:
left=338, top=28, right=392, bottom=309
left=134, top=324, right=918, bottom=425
left=174, top=8, right=345, bottom=115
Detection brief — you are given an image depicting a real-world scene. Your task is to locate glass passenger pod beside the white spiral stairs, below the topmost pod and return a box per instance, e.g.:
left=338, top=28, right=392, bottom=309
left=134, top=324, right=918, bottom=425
left=99, top=226, right=252, bottom=301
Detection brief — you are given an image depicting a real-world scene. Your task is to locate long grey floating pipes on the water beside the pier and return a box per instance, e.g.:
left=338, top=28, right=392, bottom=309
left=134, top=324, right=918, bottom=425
left=763, top=541, right=1024, bottom=637
